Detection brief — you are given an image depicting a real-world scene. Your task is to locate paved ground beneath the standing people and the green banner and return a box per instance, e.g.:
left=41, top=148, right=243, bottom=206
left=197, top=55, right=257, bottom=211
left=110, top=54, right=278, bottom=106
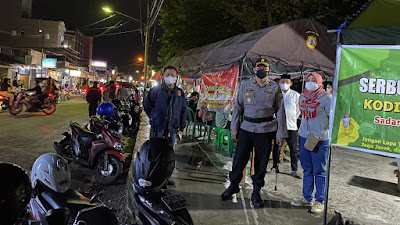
left=130, top=116, right=400, bottom=225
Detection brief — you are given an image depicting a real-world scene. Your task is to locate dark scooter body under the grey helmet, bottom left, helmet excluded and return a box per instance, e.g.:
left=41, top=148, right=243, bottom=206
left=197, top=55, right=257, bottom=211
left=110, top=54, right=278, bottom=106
left=29, top=185, right=118, bottom=225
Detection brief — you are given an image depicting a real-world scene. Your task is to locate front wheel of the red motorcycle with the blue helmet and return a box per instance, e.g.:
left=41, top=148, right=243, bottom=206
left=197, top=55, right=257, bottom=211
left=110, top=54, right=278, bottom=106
left=94, top=155, right=122, bottom=185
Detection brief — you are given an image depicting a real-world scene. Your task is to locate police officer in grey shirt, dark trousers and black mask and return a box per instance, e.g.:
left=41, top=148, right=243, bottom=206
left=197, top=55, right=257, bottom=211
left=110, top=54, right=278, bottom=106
left=221, top=58, right=287, bottom=207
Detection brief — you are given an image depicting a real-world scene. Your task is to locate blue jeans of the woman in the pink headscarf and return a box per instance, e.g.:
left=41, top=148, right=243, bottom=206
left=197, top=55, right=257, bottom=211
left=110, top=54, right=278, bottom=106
left=299, top=137, right=329, bottom=204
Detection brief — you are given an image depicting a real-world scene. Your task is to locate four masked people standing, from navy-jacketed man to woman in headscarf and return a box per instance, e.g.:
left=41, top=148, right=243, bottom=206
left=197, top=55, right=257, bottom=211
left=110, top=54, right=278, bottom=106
left=144, top=58, right=332, bottom=213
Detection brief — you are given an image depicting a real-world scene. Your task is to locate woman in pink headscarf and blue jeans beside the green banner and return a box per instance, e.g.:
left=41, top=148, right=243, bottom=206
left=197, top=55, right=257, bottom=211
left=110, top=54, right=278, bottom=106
left=292, top=73, right=332, bottom=213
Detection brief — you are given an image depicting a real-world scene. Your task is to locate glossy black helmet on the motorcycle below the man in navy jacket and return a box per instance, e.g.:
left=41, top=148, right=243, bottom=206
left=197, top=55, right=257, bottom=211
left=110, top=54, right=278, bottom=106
left=132, top=138, right=175, bottom=194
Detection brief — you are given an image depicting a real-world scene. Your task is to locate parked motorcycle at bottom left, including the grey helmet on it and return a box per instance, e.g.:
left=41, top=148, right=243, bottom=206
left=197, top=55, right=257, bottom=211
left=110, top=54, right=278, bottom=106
left=29, top=153, right=118, bottom=225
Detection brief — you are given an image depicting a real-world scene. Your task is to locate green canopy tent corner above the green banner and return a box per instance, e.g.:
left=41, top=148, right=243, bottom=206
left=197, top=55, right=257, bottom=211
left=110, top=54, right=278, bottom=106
left=340, top=0, right=400, bottom=45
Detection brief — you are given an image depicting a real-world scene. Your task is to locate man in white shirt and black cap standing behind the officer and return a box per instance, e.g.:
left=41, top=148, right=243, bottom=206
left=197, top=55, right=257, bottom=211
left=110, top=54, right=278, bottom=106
left=279, top=74, right=300, bottom=178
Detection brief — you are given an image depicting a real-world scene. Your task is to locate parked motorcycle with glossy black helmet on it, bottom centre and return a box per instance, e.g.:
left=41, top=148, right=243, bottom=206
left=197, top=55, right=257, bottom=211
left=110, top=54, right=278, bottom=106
left=128, top=138, right=193, bottom=225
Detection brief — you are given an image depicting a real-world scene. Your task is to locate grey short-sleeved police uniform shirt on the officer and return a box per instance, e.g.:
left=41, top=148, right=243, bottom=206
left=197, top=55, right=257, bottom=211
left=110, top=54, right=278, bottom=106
left=231, top=79, right=287, bottom=138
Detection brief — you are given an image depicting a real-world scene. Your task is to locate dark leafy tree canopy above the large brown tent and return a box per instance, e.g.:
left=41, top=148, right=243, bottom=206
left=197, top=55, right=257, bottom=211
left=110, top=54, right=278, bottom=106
left=159, top=0, right=366, bottom=64
